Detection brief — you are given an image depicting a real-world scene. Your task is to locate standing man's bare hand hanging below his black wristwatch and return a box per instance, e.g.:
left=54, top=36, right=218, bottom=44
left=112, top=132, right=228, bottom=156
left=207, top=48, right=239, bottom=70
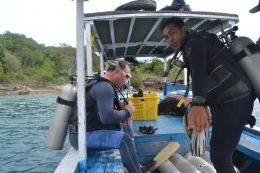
left=188, top=106, right=209, bottom=133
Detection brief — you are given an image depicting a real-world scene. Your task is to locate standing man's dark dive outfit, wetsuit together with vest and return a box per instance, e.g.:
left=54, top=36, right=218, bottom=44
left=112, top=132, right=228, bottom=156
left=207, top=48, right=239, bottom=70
left=182, top=31, right=255, bottom=173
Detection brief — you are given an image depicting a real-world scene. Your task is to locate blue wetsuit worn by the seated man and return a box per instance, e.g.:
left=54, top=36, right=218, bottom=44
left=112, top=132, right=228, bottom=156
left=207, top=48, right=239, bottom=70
left=69, top=81, right=141, bottom=173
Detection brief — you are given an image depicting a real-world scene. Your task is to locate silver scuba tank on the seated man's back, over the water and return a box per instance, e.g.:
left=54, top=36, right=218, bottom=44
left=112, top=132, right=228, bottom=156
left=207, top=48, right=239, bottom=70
left=45, top=76, right=77, bottom=150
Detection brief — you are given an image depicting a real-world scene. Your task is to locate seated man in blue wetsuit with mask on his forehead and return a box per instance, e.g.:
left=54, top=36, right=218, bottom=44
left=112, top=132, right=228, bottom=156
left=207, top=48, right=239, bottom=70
left=69, top=60, right=142, bottom=173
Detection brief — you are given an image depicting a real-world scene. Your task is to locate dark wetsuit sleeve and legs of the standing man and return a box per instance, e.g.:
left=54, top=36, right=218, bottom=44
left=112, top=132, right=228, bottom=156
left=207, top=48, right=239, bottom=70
left=183, top=33, right=256, bottom=173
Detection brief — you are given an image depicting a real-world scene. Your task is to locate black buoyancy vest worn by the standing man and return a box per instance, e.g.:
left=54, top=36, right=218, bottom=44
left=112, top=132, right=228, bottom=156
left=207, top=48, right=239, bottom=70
left=185, top=32, right=252, bottom=105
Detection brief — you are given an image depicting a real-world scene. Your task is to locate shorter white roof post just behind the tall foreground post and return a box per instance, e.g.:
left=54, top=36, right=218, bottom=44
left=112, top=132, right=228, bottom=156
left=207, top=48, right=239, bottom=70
left=85, top=21, right=93, bottom=76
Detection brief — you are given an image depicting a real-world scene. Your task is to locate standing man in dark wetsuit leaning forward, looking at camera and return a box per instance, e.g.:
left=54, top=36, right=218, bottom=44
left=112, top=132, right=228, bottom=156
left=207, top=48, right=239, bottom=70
left=160, top=17, right=255, bottom=173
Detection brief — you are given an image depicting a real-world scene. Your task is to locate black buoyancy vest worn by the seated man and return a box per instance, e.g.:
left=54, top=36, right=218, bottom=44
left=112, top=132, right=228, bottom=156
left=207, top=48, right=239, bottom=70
left=69, top=77, right=122, bottom=131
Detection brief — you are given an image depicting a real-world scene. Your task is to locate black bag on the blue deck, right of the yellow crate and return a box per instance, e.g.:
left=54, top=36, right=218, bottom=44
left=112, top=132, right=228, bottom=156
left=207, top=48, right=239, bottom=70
left=158, top=97, right=185, bottom=116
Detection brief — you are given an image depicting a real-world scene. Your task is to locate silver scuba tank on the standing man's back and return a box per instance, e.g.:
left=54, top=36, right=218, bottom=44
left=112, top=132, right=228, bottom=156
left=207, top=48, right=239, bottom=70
left=228, top=37, right=260, bottom=98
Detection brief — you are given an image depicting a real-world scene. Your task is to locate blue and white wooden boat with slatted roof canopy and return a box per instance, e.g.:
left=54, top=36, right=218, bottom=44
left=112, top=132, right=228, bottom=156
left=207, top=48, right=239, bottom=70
left=49, top=0, right=260, bottom=173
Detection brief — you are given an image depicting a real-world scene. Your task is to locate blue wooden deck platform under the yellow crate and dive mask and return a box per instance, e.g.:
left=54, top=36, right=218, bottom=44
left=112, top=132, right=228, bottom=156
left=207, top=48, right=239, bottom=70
left=130, top=115, right=190, bottom=164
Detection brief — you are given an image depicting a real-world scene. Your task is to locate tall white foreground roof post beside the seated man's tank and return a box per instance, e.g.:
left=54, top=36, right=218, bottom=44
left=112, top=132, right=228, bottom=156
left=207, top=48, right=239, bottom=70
left=76, top=0, right=87, bottom=164
